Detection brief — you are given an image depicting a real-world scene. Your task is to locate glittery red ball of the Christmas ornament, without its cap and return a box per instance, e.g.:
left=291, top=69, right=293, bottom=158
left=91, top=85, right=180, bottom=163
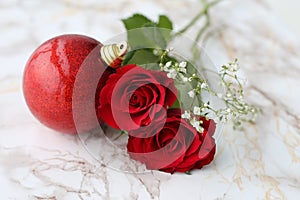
left=23, top=35, right=113, bottom=134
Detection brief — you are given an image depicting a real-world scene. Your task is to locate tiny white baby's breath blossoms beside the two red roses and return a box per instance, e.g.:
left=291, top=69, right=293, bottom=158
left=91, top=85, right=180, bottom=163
left=160, top=51, right=260, bottom=132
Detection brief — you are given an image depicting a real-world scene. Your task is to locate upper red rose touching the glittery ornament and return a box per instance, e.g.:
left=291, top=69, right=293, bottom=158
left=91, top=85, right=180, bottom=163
left=98, top=65, right=177, bottom=130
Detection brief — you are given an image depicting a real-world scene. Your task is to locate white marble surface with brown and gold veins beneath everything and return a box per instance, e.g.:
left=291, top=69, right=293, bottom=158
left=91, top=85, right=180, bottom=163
left=0, top=0, right=300, bottom=199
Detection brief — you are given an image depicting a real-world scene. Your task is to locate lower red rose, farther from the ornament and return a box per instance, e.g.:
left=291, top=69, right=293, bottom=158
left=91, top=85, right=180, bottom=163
left=127, top=109, right=216, bottom=173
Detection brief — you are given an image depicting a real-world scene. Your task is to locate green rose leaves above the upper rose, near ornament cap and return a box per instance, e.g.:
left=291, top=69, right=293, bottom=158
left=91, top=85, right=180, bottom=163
left=122, top=14, right=173, bottom=65
